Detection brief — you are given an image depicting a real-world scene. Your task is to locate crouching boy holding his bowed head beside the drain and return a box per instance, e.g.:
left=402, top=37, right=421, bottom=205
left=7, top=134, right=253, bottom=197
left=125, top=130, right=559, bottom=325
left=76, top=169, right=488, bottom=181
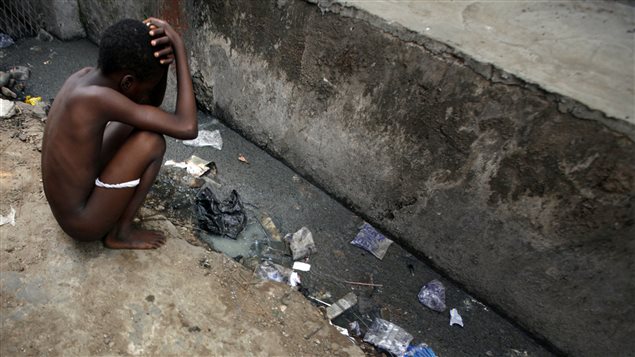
left=42, top=18, right=197, bottom=249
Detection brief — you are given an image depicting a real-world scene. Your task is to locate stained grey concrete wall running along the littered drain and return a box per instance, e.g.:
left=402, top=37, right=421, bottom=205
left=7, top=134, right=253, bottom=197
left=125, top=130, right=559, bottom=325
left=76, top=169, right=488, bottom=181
left=79, top=0, right=635, bottom=356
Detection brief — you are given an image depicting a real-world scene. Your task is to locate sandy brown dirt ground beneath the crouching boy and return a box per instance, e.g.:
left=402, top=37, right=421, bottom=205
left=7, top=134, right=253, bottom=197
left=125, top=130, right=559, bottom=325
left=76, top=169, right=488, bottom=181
left=0, top=107, right=363, bottom=356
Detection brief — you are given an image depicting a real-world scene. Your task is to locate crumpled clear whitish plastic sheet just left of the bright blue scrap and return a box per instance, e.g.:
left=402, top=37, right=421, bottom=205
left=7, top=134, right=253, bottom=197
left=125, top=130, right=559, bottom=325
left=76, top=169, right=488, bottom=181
left=364, top=318, right=413, bottom=356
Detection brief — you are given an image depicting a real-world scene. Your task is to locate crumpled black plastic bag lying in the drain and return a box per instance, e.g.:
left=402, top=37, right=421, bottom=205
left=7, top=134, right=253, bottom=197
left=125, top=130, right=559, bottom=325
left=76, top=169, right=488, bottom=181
left=196, top=187, right=247, bottom=239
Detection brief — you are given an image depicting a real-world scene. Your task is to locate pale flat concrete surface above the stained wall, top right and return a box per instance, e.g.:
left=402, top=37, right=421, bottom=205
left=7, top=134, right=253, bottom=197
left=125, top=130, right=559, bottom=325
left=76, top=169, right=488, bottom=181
left=336, top=0, right=635, bottom=123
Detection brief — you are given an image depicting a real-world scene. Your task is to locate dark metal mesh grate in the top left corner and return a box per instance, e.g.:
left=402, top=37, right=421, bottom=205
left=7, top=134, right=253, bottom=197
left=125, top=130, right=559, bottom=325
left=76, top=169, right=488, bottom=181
left=0, top=0, right=42, bottom=39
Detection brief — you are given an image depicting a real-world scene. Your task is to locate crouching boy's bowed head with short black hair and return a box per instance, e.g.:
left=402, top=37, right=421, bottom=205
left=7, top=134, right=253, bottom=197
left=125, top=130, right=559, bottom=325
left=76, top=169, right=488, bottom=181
left=97, top=19, right=166, bottom=99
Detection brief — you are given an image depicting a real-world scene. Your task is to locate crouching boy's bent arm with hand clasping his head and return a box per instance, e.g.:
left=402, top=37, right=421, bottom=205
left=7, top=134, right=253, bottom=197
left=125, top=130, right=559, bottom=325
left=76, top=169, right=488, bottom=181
left=89, top=18, right=198, bottom=139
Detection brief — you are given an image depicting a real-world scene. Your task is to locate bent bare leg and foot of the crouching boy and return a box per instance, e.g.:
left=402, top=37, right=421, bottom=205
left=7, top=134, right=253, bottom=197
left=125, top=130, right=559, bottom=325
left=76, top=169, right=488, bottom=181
left=81, top=131, right=165, bottom=249
